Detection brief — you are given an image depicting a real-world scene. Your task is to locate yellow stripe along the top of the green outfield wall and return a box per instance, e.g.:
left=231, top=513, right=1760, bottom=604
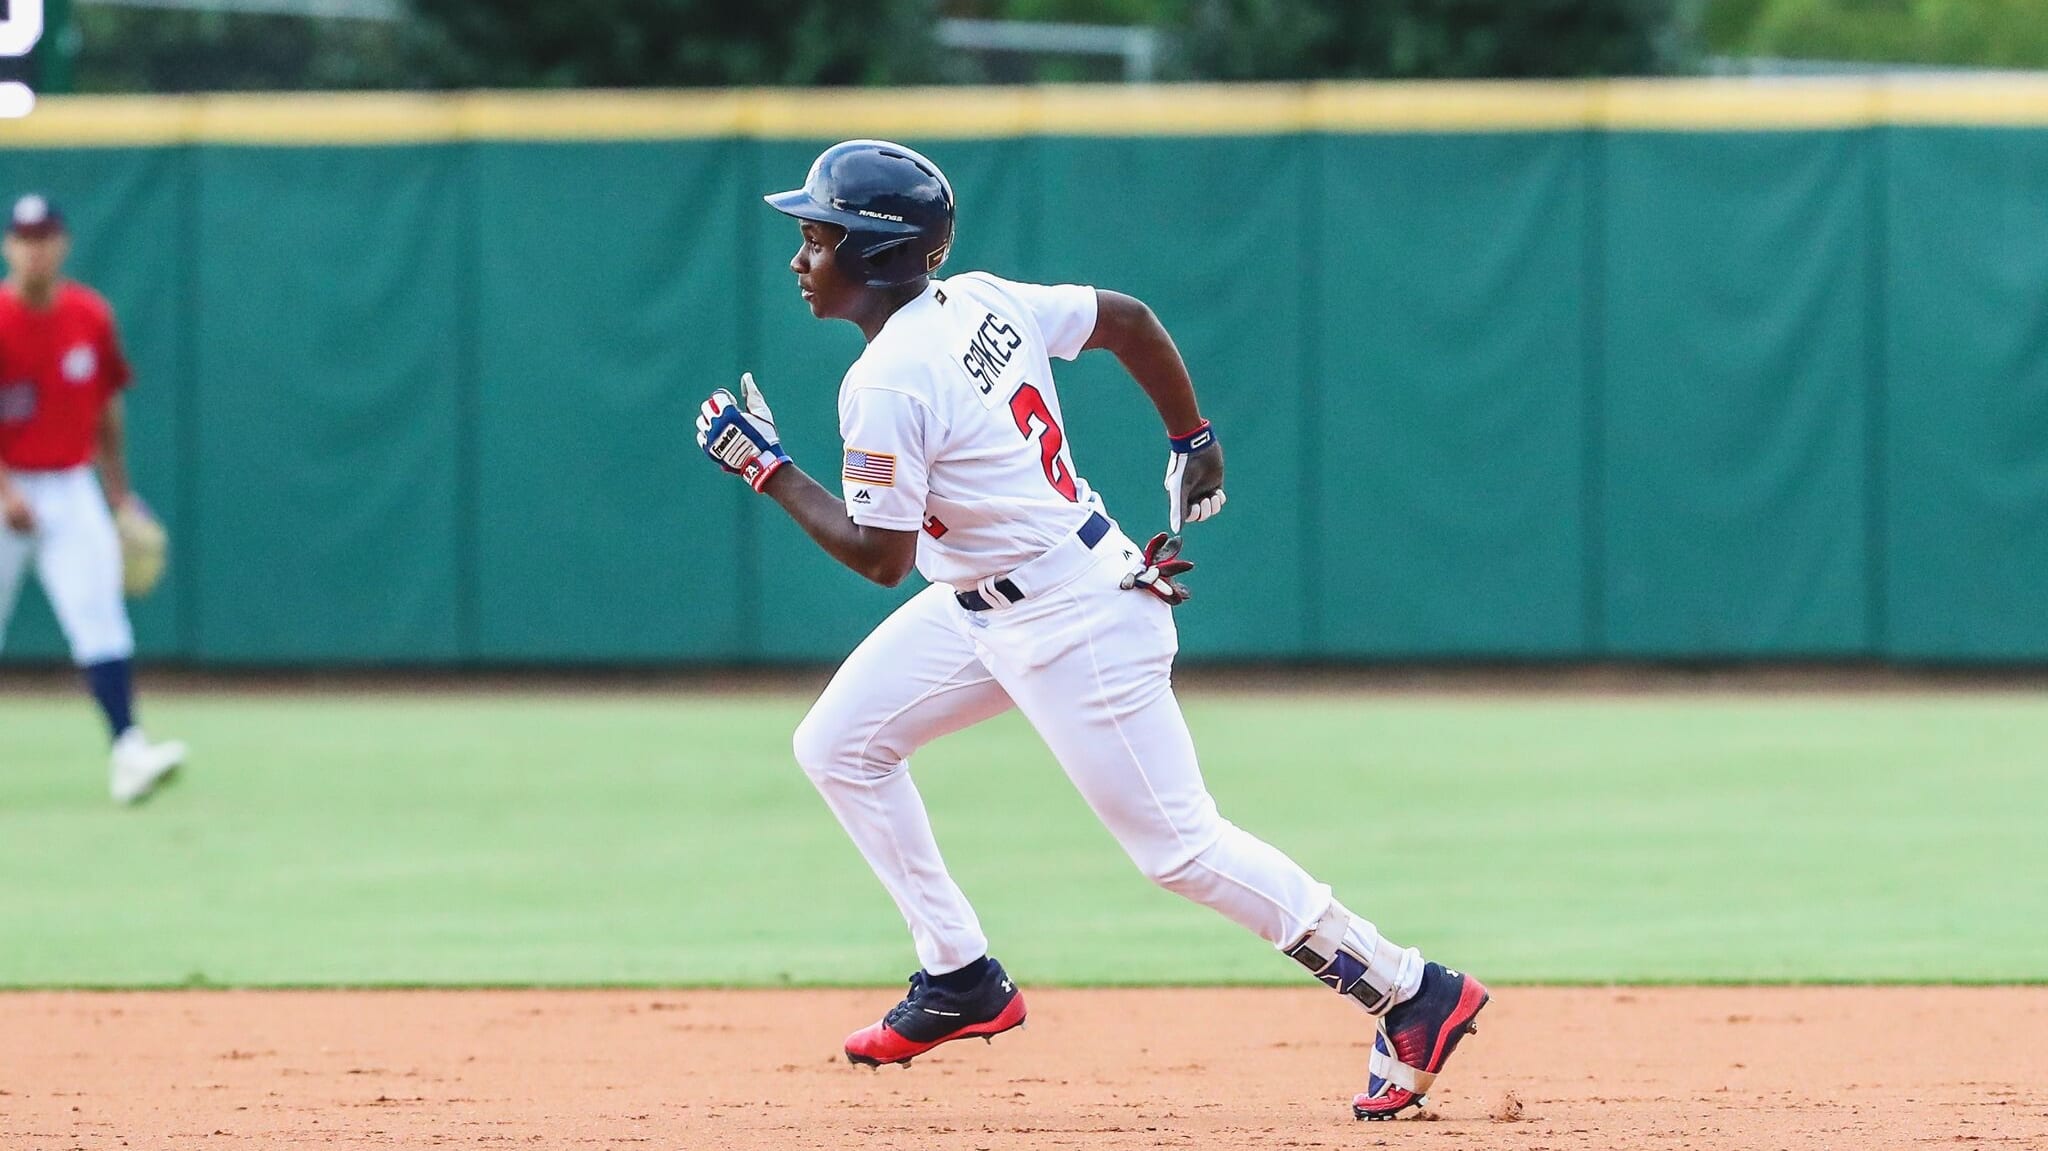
left=12, top=76, right=2048, bottom=147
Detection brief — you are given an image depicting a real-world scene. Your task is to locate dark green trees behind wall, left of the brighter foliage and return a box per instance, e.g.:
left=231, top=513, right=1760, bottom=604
left=76, top=0, right=1695, bottom=92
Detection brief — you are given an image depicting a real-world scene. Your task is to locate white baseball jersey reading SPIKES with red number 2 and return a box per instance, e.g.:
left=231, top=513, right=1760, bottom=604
left=840, top=272, right=1102, bottom=588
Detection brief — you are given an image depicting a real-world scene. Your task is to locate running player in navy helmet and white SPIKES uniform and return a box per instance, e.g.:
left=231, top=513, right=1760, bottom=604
left=696, top=139, right=1487, bottom=1118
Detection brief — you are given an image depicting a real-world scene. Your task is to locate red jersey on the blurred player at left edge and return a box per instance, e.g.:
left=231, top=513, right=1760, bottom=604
left=0, top=281, right=129, bottom=471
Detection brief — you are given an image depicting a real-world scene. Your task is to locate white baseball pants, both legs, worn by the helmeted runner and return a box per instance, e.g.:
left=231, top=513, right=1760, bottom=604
left=797, top=520, right=1421, bottom=993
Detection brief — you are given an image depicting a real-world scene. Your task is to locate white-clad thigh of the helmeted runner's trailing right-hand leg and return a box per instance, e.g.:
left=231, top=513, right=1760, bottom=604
left=978, top=584, right=1221, bottom=872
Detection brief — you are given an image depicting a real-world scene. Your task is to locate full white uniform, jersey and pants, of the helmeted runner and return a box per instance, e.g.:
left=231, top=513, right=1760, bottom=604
left=795, top=272, right=1423, bottom=1019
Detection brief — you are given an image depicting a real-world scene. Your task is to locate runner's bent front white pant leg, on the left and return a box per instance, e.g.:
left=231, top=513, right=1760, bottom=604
left=795, top=586, right=1010, bottom=973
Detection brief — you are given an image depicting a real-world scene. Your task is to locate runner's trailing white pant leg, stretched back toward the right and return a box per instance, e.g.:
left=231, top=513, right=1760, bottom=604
left=979, top=537, right=1421, bottom=991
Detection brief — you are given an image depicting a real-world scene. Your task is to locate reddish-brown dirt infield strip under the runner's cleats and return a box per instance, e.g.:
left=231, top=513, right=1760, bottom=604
left=0, top=987, right=2048, bottom=1151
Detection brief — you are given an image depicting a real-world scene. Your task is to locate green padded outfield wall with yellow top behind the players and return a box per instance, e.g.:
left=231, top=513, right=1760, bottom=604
left=0, top=80, right=2048, bottom=666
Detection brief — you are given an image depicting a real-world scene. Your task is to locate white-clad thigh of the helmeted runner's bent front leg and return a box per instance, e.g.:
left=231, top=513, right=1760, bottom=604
left=797, top=586, right=1012, bottom=774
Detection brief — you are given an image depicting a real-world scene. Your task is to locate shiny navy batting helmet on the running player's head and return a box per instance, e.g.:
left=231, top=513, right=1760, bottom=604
left=762, top=139, right=952, bottom=287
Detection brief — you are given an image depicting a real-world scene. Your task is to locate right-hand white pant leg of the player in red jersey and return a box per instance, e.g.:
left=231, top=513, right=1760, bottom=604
left=18, top=467, right=135, bottom=668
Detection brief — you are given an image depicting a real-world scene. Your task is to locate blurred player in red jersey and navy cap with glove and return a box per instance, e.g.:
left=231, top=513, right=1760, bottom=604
left=0, top=195, right=184, bottom=803
